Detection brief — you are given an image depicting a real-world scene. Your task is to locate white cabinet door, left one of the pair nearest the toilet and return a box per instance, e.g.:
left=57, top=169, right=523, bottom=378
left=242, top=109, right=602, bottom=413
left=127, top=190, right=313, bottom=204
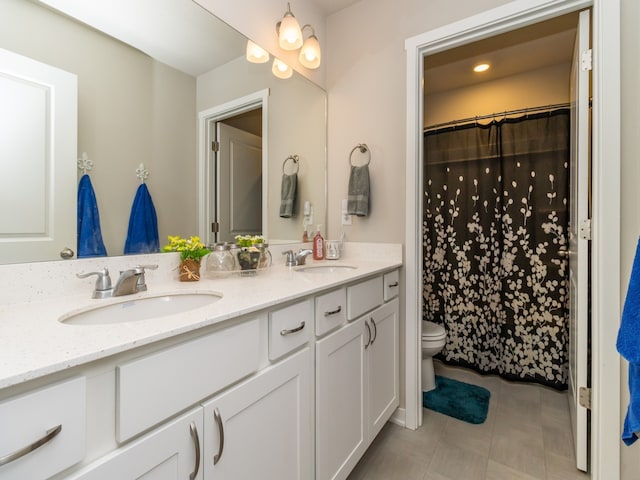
left=316, top=318, right=369, bottom=480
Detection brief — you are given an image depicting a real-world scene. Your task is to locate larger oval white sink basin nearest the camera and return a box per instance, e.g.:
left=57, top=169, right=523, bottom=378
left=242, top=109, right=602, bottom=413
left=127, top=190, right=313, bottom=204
left=59, top=292, right=222, bottom=325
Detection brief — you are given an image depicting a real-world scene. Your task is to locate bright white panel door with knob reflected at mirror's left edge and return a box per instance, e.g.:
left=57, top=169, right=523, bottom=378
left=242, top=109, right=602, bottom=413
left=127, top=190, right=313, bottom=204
left=0, top=49, right=78, bottom=263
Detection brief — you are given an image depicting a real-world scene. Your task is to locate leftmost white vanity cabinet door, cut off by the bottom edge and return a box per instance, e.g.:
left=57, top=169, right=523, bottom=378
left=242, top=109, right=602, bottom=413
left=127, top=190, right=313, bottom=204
left=70, top=407, right=203, bottom=480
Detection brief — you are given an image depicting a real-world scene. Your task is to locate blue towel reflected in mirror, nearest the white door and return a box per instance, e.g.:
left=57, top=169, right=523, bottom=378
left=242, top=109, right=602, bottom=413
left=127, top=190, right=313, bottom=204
left=77, top=174, right=107, bottom=258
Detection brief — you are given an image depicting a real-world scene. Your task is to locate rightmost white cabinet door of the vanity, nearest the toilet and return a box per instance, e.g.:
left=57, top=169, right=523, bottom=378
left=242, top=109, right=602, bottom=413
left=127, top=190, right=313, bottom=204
left=366, top=299, right=400, bottom=442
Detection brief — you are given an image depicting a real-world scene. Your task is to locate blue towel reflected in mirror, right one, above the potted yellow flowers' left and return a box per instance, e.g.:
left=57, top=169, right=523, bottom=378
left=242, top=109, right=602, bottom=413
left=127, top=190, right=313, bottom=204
left=124, top=183, right=160, bottom=254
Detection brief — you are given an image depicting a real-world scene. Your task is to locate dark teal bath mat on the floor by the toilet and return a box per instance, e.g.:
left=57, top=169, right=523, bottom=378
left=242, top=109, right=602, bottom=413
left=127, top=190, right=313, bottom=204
left=422, top=375, right=491, bottom=425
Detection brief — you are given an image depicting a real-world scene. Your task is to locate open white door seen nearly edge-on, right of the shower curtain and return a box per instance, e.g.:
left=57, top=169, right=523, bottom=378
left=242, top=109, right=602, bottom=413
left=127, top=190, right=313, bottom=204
left=568, top=10, right=591, bottom=471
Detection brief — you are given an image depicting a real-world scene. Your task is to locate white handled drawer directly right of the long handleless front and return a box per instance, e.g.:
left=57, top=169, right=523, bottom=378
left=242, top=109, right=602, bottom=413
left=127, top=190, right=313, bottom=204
left=269, top=299, right=313, bottom=360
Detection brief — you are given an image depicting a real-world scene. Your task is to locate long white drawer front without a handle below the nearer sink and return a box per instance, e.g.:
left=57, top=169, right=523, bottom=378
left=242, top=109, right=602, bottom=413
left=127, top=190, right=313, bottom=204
left=116, top=318, right=260, bottom=442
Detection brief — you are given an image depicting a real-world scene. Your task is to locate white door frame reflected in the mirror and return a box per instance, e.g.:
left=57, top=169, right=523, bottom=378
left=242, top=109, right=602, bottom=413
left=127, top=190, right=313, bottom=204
left=197, top=88, right=269, bottom=244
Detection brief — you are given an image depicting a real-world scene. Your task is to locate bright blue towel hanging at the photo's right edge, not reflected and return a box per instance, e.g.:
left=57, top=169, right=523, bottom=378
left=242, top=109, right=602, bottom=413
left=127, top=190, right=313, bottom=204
left=616, top=240, right=640, bottom=445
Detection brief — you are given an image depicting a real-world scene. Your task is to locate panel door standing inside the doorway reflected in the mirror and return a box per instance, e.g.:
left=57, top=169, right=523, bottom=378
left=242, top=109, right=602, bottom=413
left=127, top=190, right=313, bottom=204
left=215, top=122, right=262, bottom=242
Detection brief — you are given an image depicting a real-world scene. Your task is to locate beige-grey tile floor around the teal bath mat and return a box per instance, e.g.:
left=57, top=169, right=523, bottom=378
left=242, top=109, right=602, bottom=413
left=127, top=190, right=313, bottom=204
left=348, top=362, right=589, bottom=480
